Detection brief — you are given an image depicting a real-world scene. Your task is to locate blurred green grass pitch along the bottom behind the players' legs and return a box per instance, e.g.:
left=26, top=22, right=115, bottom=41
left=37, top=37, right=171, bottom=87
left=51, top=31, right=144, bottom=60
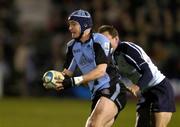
left=0, top=98, right=180, bottom=127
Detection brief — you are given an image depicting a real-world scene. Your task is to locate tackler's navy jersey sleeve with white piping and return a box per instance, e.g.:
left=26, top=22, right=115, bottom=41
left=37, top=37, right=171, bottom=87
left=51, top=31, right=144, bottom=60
left=117, top=43, right=153, bottom=90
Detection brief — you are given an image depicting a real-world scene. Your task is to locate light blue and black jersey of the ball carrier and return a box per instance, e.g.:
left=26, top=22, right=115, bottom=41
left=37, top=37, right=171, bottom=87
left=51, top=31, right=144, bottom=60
left=64, top=33, right=115, bottom=98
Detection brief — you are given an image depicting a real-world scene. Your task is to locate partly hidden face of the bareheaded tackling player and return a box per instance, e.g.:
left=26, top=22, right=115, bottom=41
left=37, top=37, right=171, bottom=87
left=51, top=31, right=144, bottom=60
left=102, top=32, right=119, bottom=49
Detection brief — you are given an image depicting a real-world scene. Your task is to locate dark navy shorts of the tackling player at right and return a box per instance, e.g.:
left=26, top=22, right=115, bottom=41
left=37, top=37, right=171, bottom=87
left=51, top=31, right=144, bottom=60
left=137, top=78, right=176, bottom=112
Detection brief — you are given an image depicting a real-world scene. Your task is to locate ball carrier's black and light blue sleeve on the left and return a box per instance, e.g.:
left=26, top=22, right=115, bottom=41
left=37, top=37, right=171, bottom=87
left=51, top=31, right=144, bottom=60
left=63, top=41, right=77, bottom=72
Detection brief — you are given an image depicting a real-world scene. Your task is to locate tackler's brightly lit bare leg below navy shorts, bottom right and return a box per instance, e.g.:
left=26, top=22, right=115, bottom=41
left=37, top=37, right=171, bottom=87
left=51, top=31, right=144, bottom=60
left=154, top=112, right=172, bottom=127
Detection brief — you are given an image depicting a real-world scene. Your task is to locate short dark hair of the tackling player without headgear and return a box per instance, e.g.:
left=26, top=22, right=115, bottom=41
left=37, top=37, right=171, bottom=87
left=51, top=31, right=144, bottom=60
left=98, top=25, right=119, bottom=37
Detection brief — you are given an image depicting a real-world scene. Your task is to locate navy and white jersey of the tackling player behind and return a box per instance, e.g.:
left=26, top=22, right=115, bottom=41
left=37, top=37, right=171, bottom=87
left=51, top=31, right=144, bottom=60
left=114, top=42, right=165, bottom=90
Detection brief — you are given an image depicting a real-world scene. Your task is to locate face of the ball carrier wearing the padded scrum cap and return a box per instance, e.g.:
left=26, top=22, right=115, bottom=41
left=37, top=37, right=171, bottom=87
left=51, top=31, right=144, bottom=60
left=68, top=20, right=81, bottom=38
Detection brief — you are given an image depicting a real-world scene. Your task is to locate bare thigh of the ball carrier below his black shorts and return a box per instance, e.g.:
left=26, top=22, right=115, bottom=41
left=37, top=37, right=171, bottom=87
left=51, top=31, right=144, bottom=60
left=90, top=96, right=118, bottom=125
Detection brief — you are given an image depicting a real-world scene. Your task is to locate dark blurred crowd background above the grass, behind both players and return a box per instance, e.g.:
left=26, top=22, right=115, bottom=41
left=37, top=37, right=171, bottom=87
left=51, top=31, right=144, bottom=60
left=0, top=0, right=180, bottom=127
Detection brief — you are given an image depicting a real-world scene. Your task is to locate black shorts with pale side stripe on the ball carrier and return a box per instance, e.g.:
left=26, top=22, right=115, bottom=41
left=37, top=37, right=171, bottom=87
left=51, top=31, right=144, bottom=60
left=91, top=80, right=127, bottom=116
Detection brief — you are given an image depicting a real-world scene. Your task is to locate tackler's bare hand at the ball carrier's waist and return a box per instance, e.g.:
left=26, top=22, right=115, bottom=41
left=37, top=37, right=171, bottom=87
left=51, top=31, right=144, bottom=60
left=127, top=84, right=141, bottom=97
